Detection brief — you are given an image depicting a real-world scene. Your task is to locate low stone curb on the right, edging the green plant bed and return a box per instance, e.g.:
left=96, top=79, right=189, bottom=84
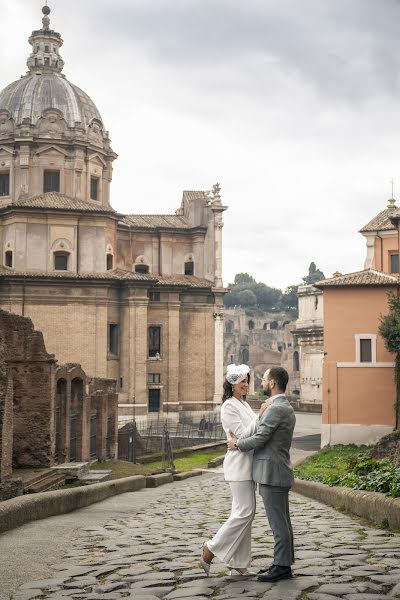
left=292, top=479, right=400, bottom=530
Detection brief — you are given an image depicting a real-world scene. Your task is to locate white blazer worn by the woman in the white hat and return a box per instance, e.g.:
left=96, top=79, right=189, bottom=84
left=221, top=397, right=257, bottom=481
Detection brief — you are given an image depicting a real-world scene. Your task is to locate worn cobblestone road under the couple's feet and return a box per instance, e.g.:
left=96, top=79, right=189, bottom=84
left=13, top=473, right=400, bottom=600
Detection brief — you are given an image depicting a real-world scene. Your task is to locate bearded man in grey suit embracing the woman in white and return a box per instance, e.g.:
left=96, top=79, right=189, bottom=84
left=228, top=367, right=296, bottom=581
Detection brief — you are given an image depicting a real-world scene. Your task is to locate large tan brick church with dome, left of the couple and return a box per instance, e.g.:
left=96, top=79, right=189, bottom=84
left=0, top=6, right=226, bottom=420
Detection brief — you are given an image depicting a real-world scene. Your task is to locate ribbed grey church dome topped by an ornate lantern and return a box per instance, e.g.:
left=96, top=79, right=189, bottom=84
left=0, top=5, right=104, bottom=130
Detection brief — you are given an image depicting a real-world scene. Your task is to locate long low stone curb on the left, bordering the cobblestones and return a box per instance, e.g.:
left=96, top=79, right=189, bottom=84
left=0, top=475, right=145, bottom=533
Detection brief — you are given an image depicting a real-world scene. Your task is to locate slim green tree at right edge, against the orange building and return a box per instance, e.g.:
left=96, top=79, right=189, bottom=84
left=379, top=291, right=400, bottom=429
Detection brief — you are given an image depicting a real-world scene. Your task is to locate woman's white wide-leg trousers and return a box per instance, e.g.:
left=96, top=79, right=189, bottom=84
left=207, top=481, right=256, bottom=569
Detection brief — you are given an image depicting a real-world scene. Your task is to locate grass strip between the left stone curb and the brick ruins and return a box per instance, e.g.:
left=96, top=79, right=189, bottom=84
left=91, top=452, right=225, bottom=479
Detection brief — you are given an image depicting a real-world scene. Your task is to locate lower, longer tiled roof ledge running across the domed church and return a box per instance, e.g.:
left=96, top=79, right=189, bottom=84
left=0, top=267, right=213, bottom=288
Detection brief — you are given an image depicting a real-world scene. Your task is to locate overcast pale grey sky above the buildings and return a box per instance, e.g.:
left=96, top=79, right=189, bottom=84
left=0, top=0, right=400, bottom=288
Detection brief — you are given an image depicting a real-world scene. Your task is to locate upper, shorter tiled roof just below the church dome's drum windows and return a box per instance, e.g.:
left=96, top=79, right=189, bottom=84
left=0, top=192, right=115, bottom=213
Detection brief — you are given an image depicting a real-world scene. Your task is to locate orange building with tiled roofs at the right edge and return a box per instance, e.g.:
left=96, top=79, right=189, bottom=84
left=316, top=200, right=400, bottom=446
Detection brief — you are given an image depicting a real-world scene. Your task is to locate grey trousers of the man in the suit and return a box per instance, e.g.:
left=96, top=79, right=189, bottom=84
left=260, top=483, right=294, bottom=567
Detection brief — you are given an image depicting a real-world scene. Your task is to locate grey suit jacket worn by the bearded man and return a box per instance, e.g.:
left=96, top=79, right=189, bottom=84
left=237, top=395, right=296, bottom=487
